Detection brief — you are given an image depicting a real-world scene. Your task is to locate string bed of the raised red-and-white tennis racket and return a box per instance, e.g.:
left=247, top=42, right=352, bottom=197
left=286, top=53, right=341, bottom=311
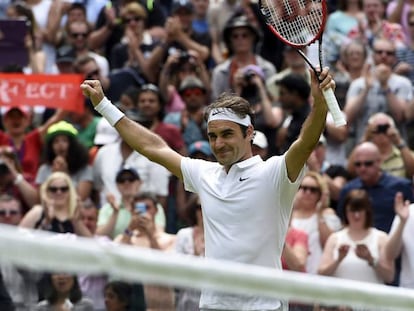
left=261, top=0, right=323, bottom=45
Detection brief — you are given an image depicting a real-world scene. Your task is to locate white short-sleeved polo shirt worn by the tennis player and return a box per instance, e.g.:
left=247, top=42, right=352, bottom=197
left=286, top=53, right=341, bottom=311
left=181, top=156, right=304, bottom=310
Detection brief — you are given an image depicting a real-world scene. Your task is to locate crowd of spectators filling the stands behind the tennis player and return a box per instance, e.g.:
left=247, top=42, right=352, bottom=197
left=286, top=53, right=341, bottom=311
left=0, top=0, right=414, bottom=311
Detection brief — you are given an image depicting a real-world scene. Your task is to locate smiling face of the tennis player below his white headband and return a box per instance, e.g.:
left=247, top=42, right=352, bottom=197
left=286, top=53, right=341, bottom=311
left=208, top=120, right=254, bottom=170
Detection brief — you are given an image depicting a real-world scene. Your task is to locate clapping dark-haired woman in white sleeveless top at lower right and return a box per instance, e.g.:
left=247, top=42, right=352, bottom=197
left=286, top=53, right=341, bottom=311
left=318, top=189, right=394, bottom=284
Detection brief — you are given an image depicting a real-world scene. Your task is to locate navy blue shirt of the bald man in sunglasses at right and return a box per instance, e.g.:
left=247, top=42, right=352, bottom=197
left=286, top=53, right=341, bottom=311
left=338, top=172, right=413, bottom=233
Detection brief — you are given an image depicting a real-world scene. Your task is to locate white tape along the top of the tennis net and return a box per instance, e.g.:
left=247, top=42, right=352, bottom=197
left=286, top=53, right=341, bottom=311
left=0, top=225, right=414, bottom=310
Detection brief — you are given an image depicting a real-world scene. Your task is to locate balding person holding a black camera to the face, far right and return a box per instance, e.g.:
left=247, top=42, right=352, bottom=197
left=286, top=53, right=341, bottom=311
left=348, top=112, right=414, bottom=180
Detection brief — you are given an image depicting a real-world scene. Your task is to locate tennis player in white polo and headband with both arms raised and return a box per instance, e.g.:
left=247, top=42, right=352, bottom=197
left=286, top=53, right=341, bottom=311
left=81, top=68, right=335, bottom=311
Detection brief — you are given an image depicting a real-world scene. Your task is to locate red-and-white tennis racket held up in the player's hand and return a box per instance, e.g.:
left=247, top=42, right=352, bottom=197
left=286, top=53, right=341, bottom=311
left=259, top=0, right=346, bottom=126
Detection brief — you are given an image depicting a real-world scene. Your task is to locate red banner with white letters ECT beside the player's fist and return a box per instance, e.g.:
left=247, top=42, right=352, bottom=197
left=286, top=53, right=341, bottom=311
left=0, top=73, right=85, bottom=113
